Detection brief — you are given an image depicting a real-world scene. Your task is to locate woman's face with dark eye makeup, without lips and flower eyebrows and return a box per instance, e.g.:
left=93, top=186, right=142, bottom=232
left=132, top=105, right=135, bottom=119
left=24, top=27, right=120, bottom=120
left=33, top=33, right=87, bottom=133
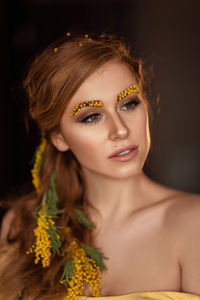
left=52, top=62, right=150, bottom=178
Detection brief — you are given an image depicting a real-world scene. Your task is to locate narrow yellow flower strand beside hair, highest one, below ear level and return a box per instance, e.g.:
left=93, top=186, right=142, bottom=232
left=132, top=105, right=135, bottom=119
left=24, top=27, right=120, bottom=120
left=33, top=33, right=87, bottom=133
left=31, top=133, right=47, bottom=194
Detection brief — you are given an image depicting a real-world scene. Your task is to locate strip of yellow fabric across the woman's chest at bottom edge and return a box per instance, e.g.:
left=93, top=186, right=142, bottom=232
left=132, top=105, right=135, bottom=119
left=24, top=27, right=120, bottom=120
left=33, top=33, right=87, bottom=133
left=80, top=291, right=200, bottom=300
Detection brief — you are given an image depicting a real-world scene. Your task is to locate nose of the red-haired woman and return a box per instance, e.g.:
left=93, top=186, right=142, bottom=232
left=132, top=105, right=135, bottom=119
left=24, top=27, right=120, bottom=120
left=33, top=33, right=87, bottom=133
left=108, top=111, right=129, bottom=140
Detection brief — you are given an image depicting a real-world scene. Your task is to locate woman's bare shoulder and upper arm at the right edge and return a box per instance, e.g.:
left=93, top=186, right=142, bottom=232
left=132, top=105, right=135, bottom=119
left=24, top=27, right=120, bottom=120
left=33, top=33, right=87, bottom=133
left=162, top=192, right=200, bottom=295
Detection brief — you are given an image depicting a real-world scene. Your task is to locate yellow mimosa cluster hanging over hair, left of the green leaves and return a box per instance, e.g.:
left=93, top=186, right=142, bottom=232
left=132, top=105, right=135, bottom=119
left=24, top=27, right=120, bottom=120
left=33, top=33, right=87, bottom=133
left=26, top=208, right=55, bottom=268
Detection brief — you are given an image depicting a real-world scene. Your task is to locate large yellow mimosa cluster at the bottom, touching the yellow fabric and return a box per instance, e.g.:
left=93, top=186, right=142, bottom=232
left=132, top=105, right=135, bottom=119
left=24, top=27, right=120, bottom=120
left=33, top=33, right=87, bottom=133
left=60, top=240, right=101, bottom=300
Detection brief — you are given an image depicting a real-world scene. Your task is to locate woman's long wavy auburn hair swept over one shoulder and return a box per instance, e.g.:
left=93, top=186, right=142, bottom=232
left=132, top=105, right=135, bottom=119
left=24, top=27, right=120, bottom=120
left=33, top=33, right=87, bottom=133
left=0, top=34, right=151, bottom=300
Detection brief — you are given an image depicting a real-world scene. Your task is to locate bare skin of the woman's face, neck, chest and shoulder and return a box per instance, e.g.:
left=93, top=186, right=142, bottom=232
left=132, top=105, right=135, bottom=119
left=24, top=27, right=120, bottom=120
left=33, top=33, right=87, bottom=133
left=51, top=62, right=200, bottom=296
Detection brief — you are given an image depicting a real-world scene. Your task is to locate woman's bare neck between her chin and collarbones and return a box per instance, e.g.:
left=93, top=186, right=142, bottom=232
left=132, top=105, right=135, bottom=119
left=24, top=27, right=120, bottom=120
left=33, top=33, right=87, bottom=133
left=81, top=170, right=158, bottom=222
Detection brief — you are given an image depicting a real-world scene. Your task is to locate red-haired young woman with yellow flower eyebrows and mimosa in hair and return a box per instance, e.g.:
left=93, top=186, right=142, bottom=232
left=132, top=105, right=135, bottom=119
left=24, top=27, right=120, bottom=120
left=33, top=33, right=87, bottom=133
left=0, top=33, right=200, bottom=300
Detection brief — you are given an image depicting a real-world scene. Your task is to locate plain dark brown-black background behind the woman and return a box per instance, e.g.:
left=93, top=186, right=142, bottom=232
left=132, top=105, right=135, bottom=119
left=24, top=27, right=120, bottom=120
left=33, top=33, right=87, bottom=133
left=0, top=0, right=200, bottom=204
